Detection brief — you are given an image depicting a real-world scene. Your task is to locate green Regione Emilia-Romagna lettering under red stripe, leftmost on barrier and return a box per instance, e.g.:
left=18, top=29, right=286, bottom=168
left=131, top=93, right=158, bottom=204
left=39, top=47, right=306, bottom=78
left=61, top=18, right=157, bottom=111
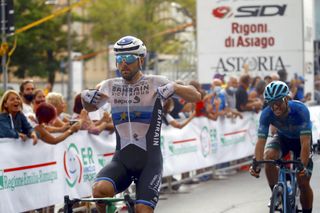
left=0, top=161, right=58, bottom=191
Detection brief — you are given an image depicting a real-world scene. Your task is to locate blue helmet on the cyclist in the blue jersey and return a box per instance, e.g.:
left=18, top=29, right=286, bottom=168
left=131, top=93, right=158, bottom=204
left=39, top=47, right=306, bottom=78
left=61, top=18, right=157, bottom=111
left=263, top=81, right=289, bottom=103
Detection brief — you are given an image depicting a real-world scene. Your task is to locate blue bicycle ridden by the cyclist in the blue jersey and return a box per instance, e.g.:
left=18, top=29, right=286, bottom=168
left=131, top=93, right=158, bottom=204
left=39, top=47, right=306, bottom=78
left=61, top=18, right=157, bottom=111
left=252, top=159, right=303, bottom=213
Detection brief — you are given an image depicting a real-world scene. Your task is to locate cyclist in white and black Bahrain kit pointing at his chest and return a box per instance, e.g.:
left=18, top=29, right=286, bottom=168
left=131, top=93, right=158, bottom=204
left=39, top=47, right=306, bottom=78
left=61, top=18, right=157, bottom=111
left=81, top=36, right=200, bottom=213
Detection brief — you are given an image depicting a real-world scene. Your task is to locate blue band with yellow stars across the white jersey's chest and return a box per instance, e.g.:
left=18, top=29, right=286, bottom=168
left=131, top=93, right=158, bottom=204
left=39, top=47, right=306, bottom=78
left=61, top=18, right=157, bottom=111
left=112, top=111, right=152, bottom=125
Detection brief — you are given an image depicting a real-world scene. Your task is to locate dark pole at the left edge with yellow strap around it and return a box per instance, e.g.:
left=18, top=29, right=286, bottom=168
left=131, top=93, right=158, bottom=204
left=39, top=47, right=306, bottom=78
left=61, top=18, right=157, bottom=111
left=1, top=0, right=8, bottom=91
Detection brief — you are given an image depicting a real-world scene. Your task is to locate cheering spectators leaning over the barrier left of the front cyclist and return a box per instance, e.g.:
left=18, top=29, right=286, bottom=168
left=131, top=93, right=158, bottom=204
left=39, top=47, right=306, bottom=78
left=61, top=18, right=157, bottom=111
left=0, top=80, right=114, bottom=145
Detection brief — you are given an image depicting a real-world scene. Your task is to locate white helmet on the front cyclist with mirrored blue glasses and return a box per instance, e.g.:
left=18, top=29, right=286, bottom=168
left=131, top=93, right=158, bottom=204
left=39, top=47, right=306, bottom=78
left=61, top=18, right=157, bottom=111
left=113, top=36, right=147, bottom=57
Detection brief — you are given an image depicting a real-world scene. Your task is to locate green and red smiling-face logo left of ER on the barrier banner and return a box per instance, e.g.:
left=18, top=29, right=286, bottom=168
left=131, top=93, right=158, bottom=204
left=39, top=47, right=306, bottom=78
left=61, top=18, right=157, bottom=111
left=63, top=143, right=83, bottom=188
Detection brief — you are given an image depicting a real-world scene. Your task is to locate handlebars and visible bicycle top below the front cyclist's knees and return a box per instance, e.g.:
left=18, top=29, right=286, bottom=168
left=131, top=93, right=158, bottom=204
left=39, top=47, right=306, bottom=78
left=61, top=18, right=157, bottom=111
left=63, top=194, right=135, bottom=213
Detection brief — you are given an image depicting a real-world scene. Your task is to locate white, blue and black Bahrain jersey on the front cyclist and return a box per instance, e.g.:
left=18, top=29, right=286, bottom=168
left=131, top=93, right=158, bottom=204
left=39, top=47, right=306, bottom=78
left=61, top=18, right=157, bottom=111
left=100, top=75, right=170, bottom=152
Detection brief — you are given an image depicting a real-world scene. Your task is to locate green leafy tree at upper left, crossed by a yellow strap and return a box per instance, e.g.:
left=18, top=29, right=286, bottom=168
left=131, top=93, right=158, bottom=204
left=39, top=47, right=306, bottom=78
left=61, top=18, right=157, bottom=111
left=9, top=0, right=89, bottom=85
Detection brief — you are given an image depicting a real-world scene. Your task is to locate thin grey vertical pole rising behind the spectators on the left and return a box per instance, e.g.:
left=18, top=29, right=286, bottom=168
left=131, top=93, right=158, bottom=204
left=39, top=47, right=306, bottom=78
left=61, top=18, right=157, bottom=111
left=67, top=0, right=73, bottom=113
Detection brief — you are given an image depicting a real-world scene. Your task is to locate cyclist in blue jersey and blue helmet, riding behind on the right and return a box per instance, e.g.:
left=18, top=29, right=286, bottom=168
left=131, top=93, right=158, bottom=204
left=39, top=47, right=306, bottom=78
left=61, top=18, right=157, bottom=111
left=249, top=81, right=313, bottom=213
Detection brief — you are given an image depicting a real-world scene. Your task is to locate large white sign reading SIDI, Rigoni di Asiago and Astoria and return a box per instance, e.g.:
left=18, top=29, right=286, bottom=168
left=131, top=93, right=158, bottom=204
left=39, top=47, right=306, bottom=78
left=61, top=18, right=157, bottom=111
left=197, top=0, right=304, bottom=83
